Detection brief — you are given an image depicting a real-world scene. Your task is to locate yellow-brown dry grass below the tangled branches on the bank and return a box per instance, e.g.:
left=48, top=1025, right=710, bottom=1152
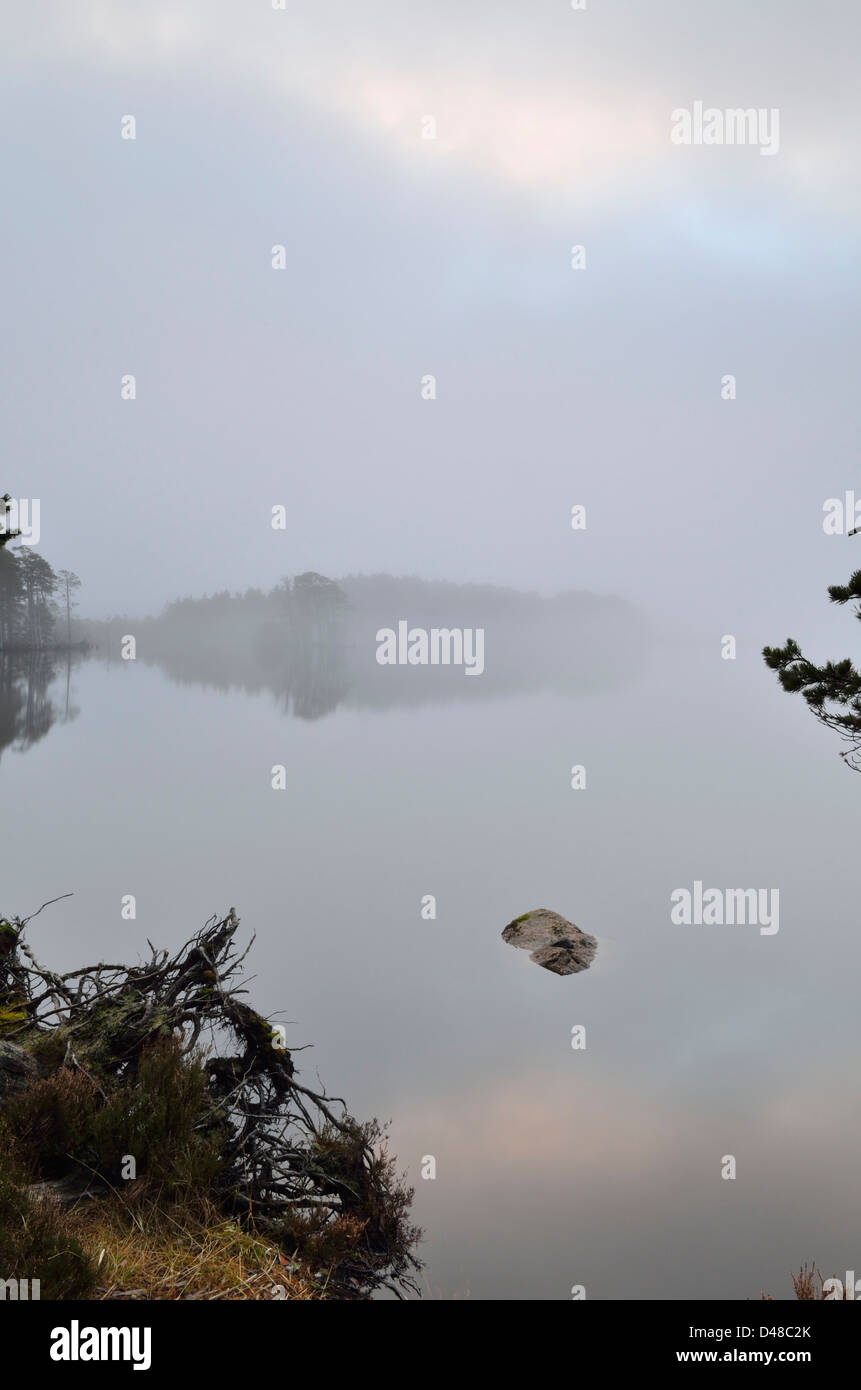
left=64, top=1197, right=325, bottom=1302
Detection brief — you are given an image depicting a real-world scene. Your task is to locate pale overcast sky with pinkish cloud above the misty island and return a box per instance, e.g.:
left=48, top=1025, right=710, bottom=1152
left=0, top=0, right=861, bottom=655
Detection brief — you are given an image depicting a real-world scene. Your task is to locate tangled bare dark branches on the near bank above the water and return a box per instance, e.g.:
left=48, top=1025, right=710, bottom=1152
left=0, top=908, right=420, bottom=1298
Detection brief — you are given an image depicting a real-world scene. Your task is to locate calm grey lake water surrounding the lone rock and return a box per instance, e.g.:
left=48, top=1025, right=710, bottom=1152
left=0, top=641, right=861, bottom=1300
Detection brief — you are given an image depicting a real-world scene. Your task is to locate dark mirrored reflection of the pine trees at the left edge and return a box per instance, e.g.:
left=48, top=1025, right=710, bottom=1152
left=0, top=652, right=79, bottom=756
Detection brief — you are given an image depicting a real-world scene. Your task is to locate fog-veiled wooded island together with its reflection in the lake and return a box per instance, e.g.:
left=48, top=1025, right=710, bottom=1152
left=80, top=574, right=650, bottom=719
